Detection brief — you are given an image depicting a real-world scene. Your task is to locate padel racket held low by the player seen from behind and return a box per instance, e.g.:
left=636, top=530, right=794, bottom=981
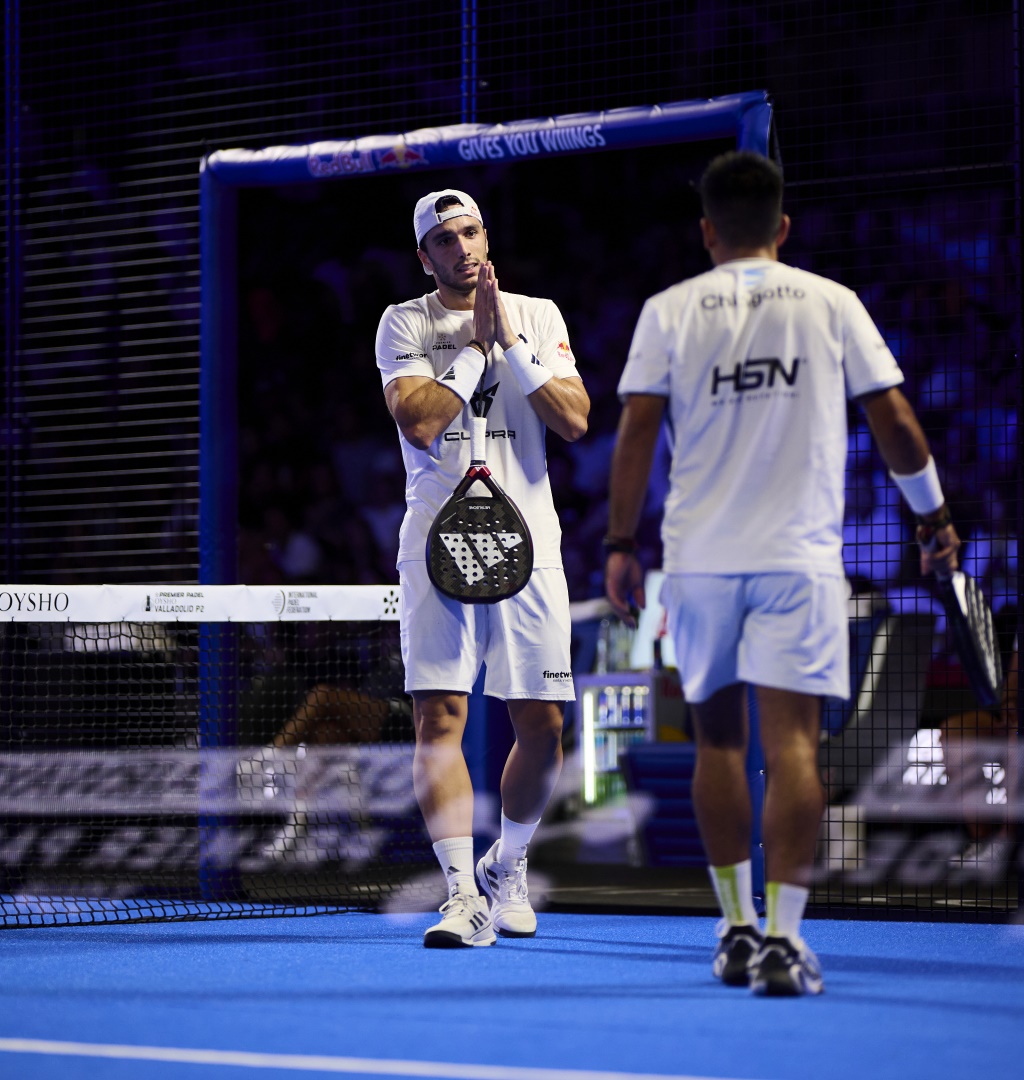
left=920, top=526, right=1002, bottom=708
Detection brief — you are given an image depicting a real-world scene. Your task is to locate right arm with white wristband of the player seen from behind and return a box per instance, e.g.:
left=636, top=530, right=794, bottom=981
left=858, top=387, right=960, bottom=575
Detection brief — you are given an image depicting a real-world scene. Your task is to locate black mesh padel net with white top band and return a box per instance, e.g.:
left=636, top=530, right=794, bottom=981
left=0, top=585, right=432, bottom=926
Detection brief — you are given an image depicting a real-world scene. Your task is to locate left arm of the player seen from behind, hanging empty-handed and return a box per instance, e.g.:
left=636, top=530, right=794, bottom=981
left=605, top=394, right=666, bottom=626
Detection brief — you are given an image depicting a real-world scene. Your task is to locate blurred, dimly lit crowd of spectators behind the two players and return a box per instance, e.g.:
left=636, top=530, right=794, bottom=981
left=240, top=159, right=1020, bottom=669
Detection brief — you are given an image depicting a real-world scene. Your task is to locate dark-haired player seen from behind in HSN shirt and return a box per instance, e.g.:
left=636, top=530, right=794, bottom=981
left=605, top=151, right=959, bottom=995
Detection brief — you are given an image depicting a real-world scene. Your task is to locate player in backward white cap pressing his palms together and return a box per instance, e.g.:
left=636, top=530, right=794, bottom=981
left=377, top=189, right=590, bottom=947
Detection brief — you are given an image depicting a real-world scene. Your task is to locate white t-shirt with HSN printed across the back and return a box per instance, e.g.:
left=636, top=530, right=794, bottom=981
left=619, top=259, right=903, bottom=575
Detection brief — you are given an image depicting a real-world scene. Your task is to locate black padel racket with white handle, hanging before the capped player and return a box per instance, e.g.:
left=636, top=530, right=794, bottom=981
left=427, top=416, right=534, bottom=604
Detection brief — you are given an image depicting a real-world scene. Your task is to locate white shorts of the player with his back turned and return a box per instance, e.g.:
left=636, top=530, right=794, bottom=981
left=661, top=573, right=850, bottom=704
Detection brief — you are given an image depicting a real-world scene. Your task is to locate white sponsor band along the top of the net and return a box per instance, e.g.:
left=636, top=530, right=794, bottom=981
left=0, top=584, right=399, bottom=623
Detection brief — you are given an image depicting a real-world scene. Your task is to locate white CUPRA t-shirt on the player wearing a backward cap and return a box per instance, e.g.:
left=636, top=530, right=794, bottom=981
left=377, top=293, right=578, bottom=569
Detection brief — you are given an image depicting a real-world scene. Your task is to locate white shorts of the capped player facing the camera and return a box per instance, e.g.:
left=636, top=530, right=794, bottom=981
left=399, top=563, right=576, bottom=701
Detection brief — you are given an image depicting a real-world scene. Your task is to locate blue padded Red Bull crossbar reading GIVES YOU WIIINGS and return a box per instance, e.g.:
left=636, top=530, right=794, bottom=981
left=202, top=91, right=771, bottom=184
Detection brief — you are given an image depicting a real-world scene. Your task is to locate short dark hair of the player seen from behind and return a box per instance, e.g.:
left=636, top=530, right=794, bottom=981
left=699, top=150, right=782, bottom=247
